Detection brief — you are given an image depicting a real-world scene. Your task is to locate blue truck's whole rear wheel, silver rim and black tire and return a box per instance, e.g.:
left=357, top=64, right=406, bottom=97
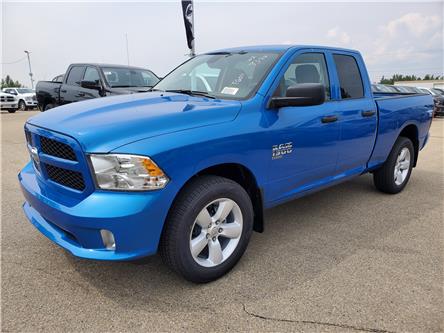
left=373, top=137, right=415, bottom=194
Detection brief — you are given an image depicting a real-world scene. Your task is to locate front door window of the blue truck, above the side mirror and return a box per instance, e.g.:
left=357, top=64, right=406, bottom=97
left=274, top=53, right=330, bottom=100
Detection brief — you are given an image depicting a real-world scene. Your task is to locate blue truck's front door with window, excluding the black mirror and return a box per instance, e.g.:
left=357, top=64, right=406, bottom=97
left=266, top=52, right=340, bottom=204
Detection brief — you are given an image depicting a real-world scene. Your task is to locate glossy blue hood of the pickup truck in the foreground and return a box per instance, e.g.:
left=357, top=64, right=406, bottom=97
left=28, top=92, right=241, bottom=153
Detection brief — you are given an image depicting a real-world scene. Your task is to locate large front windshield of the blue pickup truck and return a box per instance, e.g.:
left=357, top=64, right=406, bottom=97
left=154, top=52, right=280, bottom=99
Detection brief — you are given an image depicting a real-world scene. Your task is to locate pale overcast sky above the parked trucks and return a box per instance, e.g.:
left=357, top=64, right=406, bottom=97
left=1, top=0, right=444, bottom=85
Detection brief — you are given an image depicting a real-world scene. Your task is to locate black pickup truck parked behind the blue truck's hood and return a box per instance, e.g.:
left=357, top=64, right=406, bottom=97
left=36, top=63, right=159, bottom=111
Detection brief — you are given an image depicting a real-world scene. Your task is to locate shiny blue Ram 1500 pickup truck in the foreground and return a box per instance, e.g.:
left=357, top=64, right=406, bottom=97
left=18, top=46, right=433, bottom=282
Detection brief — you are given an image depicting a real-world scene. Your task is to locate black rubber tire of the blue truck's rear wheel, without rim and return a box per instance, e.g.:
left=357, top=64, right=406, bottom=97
left=373, top=136, right=415, bottom=194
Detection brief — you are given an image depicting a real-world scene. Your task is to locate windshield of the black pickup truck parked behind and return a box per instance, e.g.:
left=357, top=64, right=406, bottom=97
left=102, top=67, right=159, bottom=88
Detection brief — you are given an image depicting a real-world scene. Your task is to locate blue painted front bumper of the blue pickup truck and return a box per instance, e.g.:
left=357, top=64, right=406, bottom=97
left=18, top=163, right=172, bottom=260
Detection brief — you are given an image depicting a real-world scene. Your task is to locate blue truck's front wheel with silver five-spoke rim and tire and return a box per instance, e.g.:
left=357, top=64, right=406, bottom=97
left=160, top=176, right=253, bottom=283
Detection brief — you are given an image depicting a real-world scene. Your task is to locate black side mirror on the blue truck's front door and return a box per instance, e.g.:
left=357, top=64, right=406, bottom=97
left=268, top=83, right=325, bottom=108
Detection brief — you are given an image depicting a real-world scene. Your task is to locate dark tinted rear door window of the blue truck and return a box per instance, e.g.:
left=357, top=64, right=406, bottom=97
left=333, top=54, right=364, bottom=99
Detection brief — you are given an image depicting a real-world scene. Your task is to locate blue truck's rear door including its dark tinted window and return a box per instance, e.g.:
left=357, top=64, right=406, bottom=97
left=330, top=51, right=378, bottom=175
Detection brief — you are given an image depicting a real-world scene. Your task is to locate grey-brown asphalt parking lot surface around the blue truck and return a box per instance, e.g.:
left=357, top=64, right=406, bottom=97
left=1, top=112, right=444, bottom=332
